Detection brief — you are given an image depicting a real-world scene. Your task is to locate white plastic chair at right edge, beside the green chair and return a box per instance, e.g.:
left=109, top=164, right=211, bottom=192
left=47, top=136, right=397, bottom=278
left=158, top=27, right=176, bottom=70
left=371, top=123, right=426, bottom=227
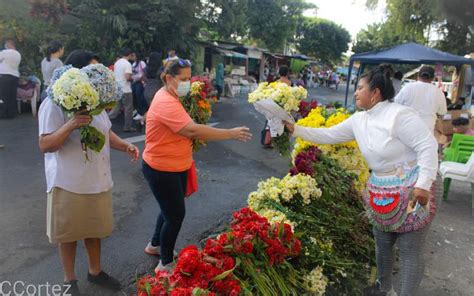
left=439, top=153, right=474, bottom=215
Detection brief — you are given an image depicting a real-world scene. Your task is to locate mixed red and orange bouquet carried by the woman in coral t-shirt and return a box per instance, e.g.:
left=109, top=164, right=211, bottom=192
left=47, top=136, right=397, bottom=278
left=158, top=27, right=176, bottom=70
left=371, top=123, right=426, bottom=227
left=180, top=77, right=213, bottom=151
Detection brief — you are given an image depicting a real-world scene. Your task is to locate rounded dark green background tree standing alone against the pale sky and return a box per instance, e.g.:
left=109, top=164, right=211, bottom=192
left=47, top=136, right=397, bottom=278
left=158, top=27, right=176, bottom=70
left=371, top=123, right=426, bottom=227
left=297, top=18, right=351, bottom=64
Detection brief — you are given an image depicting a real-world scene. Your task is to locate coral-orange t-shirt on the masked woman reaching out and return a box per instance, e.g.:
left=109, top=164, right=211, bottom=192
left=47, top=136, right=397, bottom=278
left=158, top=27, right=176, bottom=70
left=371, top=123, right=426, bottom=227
left=143, top=87, right=193, bottom=172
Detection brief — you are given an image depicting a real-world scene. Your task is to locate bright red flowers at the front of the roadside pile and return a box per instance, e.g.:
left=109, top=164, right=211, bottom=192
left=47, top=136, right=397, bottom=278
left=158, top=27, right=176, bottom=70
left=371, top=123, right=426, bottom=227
left=138, top=208, right=301, bottom=296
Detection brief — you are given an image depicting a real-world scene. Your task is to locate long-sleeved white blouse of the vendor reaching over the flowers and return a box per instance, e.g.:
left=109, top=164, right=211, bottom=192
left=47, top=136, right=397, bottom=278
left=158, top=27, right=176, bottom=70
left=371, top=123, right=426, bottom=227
left=293, top=102, right=438, bottom=190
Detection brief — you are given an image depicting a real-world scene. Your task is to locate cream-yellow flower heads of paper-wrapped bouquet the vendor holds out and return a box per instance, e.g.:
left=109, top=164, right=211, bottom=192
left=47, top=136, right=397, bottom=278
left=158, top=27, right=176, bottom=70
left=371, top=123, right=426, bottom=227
left=248, top=81, right=308, bottom=113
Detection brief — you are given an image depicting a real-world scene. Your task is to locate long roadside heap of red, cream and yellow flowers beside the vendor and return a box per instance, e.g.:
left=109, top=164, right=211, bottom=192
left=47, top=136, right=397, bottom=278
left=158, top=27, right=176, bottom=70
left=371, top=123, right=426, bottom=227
left=138, top=100, right=375, bottom=296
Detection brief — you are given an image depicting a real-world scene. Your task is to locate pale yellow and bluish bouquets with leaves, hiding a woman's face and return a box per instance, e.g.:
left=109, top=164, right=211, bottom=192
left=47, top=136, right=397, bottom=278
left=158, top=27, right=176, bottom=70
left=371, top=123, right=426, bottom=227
left=47, top=64, right=120, bottom=160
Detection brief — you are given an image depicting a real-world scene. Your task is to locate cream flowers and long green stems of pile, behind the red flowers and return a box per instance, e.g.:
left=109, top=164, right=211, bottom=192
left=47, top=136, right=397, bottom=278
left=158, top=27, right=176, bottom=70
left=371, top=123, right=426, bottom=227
left=248, top=151, right=373, bottom=295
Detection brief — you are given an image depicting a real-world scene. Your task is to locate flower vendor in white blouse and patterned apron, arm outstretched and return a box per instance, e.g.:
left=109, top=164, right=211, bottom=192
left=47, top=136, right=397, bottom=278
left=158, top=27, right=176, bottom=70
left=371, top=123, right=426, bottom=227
left=285, top=65, right=438, bottom=296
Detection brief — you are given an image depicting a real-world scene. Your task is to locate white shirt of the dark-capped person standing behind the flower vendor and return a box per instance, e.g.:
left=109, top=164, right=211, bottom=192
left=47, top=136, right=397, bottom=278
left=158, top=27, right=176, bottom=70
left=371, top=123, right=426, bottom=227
left=395, top=81, right=448, bottom=133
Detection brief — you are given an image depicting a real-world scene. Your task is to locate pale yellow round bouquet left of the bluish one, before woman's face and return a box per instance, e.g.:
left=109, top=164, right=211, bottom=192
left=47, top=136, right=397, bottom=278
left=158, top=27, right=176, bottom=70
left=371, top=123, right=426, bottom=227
left=52, top=68, right=100, bottom=112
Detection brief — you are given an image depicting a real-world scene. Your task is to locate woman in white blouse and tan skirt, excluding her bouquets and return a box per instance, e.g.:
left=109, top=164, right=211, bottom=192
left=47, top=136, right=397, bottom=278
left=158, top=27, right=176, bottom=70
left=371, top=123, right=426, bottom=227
left=39, top=50, right=139, bottom=296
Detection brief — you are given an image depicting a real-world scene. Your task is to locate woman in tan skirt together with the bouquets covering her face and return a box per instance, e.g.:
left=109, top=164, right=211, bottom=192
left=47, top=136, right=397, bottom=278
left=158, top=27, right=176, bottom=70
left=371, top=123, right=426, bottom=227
left=39, top=50, right=139, bottom=295
